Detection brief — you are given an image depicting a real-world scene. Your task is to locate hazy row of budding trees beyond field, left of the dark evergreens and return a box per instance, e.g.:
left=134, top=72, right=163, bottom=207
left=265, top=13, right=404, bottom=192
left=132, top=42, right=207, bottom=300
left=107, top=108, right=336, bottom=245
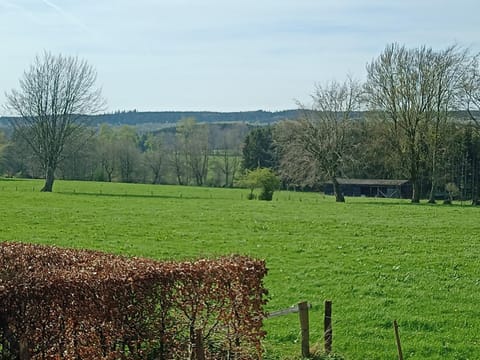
left=0, top=118, right=251, bottom=187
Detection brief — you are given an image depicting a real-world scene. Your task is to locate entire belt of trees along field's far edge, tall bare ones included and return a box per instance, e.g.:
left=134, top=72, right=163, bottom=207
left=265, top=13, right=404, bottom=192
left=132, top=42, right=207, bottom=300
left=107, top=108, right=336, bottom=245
left=0, top=43, right=480, bottom=204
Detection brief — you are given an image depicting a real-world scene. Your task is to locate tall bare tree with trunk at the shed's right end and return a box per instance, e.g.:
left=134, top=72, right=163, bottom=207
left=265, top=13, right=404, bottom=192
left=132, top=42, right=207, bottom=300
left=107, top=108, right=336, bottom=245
left=365, top=44, right=435, bottom=203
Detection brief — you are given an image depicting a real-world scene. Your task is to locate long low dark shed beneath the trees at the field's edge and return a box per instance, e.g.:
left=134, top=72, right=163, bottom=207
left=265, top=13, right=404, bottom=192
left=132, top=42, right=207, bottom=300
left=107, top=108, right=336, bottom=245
left=324, top=179, right=412, bottom=198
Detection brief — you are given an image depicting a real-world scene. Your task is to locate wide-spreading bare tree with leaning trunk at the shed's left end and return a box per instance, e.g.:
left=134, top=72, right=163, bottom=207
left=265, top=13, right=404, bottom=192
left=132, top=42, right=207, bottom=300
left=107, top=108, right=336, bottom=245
left=276, top=78, right=361, bottom=202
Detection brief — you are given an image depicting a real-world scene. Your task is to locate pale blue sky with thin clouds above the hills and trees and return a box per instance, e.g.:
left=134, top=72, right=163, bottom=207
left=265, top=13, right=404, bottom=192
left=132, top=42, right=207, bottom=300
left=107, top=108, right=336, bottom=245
left=0, top=0, right=480, bottom=115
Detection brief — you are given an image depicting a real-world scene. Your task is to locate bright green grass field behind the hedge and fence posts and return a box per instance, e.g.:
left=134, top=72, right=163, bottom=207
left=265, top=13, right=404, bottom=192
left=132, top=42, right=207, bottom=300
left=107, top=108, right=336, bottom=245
left=0, top=180, right=480, bottom=360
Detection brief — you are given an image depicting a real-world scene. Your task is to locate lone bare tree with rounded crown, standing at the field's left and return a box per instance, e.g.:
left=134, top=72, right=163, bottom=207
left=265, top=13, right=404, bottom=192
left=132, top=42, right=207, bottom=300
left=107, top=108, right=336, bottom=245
left=6, top=52, right=105, bottom=192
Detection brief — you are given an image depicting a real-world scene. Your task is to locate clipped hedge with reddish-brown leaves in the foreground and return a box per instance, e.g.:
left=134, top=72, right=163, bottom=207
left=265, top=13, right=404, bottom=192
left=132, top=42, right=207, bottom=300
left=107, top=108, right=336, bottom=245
left=0, top=242, right=267, bottom=360
